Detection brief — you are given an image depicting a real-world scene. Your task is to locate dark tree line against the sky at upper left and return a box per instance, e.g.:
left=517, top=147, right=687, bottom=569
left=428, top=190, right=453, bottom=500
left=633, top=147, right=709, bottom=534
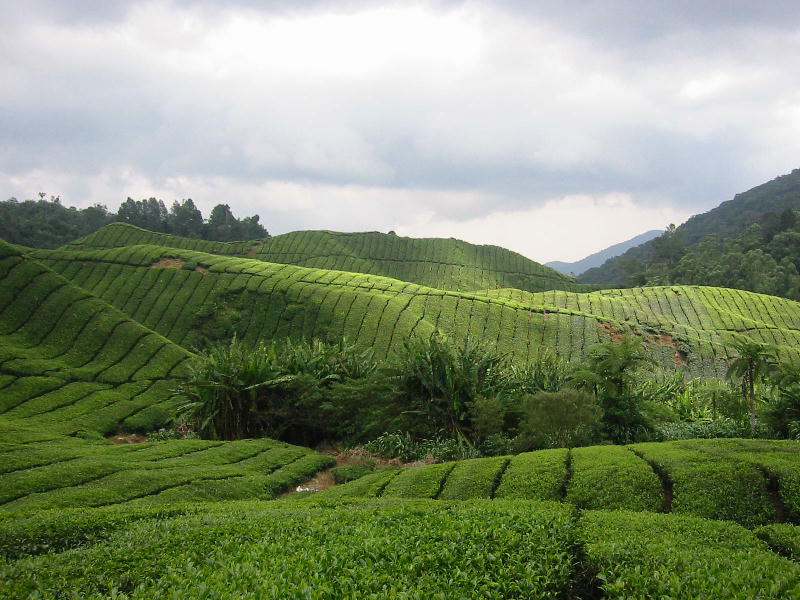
left=0, top=193, right=269, bottom=248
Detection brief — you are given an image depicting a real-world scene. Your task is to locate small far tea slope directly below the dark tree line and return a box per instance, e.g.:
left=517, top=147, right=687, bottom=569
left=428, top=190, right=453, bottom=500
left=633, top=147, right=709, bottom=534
left=64, top=223, right=262, bottom=256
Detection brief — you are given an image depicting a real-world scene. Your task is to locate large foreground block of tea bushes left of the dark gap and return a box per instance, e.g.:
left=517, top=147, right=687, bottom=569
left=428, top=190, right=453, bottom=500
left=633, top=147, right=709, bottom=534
left=0, top=501, right=578, bottom=600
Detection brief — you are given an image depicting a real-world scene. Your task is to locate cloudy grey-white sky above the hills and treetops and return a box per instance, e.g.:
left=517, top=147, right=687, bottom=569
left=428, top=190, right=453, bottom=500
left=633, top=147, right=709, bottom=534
left=0, top=0, right=800, bottom=262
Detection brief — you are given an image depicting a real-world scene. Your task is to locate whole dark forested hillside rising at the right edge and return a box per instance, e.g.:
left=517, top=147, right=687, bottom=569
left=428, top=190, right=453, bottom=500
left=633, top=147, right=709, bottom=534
left=579, top=169, right=800, bottom=300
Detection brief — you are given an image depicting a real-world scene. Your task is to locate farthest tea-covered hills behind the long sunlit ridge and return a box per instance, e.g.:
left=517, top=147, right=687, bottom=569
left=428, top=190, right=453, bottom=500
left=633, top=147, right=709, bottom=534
left=65, top=223, right=596, bottom=292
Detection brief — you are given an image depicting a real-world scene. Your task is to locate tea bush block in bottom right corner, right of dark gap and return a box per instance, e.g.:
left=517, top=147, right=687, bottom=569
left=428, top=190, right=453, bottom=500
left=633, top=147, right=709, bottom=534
left=581, top=511, right=800, bottom=600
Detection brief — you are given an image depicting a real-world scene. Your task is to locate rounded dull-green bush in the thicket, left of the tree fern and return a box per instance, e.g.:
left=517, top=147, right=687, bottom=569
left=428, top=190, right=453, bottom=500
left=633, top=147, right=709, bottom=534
left=517, top=389, right=603, bottom=451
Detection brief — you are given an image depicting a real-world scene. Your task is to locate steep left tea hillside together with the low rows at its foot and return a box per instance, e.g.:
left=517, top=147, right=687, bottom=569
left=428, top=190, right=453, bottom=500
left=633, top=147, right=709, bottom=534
left=0, top=242, right=340, bottom=512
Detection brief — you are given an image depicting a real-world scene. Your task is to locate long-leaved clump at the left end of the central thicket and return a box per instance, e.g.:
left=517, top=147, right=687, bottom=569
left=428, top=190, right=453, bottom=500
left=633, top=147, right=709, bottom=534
left=179, top=337, right=376, bottom=443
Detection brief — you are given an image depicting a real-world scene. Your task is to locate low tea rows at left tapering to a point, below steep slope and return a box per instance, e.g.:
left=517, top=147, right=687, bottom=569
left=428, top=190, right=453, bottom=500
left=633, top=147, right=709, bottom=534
left=0, top=423, right=333, bottom=512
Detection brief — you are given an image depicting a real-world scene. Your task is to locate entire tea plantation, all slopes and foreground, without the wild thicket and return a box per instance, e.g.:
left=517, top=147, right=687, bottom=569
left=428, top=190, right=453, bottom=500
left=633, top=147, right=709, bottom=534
left=0, top=230, right=800, bottom=600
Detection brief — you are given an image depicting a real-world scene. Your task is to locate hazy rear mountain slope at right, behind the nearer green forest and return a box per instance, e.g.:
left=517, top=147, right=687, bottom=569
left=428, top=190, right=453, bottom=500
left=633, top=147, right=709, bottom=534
left=578, top=169, right=800, bottom=293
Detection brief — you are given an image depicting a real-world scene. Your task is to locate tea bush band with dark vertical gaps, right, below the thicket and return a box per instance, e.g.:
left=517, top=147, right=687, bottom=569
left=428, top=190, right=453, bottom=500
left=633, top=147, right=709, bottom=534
left=320, top=440, right=800, bottom=527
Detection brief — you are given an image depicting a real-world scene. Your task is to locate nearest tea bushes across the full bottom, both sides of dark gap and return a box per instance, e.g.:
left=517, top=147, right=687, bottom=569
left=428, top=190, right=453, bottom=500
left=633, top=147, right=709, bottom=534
left=0, top=500, right=800, bottom=600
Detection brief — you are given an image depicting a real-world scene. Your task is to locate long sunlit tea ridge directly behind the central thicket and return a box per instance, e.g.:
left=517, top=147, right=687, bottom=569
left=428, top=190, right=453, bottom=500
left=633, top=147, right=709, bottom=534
left=33, top=245, right=800, bottom=375
